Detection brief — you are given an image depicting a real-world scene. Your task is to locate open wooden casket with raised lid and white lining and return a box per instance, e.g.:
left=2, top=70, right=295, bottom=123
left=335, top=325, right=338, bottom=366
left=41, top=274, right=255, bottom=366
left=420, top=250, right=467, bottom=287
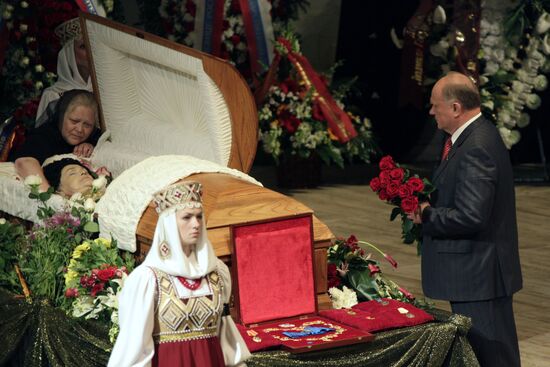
left=80, top=14, right=333, bottom=301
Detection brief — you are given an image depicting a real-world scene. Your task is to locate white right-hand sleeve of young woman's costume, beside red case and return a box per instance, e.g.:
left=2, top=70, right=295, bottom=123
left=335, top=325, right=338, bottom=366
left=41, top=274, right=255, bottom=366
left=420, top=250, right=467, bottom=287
left=217, top=259, right=251, bottom=367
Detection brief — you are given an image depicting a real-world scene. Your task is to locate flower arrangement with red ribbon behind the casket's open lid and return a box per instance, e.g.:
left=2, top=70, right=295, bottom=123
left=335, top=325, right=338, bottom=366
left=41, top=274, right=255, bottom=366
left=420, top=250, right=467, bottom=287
left=258, top=32, right=377, bottom=167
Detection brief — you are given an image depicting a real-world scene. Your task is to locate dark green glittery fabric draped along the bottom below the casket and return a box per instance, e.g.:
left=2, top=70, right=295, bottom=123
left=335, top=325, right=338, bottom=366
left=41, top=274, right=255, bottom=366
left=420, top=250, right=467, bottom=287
left=0, top=289, right=479, bottom=367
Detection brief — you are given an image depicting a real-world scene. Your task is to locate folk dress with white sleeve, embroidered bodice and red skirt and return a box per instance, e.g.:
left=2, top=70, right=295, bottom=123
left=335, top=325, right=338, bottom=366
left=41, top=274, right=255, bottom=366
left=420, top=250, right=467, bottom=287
left=109, top=260, right=234, bottom=367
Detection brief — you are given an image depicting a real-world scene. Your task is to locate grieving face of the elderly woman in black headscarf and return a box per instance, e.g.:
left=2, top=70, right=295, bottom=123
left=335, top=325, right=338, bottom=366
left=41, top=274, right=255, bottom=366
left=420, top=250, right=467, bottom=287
left=61, top=105, right=95, bottom=145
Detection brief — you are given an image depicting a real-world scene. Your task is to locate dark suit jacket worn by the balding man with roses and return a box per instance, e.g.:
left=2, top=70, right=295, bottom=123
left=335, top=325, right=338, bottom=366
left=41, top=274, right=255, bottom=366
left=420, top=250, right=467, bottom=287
left=422, top=117, right=522, bottom=301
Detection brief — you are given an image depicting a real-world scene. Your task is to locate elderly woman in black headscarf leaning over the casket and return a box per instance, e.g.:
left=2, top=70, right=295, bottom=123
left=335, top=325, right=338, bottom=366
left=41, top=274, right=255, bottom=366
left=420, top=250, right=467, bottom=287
left=10, top=89, right=100, bottom=191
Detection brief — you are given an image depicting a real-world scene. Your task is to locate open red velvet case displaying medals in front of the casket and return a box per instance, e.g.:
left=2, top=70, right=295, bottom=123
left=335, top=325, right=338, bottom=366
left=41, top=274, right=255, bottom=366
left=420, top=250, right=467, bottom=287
left=231, top=215, right=374, bottom=353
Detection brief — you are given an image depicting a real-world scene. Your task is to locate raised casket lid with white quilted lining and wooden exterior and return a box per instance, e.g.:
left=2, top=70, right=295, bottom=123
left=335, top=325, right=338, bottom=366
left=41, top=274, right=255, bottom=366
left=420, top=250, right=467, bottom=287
left=80, top=13, right=258, bottom=172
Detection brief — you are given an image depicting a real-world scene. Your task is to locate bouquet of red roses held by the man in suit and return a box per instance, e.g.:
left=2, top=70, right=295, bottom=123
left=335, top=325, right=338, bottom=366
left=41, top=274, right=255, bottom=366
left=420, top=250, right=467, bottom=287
left=369, top=155, right=435, bottom=254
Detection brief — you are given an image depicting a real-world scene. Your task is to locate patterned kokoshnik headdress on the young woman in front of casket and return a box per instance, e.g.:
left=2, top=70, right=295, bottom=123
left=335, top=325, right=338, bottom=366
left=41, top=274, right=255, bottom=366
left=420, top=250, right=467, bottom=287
left=153, top=181, right=202, bottom=214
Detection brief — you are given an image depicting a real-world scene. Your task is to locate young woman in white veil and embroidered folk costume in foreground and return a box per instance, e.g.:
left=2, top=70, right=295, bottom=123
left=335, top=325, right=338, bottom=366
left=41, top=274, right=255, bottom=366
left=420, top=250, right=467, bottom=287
left=109, top=182, right=250, bottom=367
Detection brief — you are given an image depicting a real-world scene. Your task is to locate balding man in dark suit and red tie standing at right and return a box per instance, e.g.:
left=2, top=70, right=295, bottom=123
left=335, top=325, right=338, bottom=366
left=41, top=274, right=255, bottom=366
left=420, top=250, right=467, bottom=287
left=409, top=72, right=522, bottom=367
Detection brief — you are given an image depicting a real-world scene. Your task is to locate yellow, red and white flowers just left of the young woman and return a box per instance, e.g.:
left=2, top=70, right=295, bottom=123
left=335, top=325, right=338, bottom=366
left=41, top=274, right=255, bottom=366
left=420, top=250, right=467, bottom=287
left=64, top=238, right=134, bottom=343
